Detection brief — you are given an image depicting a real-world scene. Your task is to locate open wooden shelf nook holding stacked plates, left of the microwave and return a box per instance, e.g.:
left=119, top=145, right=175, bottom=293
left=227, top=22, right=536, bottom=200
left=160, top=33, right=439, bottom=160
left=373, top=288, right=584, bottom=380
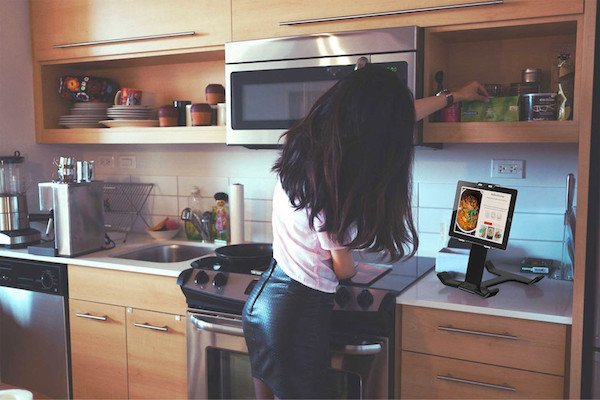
left=34, top=46, right=225, bottom=144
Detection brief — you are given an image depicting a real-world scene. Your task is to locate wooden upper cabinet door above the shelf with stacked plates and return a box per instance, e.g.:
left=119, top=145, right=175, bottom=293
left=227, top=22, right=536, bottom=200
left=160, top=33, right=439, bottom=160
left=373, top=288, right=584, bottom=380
left=30, top=0, right=231, bottom=61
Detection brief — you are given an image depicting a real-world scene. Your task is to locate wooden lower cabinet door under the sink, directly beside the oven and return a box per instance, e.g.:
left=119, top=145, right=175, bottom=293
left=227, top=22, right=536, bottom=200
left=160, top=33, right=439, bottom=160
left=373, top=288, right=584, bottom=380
left=127, top=309, right=187, bottom=399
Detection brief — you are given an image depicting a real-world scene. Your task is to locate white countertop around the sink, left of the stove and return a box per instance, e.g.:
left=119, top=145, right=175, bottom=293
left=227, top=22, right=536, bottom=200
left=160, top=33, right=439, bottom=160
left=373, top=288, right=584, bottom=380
left=0, top=233, right=216, bottom=277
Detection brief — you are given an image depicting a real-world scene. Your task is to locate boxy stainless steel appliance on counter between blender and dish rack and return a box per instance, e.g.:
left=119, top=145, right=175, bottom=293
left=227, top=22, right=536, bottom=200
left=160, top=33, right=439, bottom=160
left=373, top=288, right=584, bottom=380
left=37, top=182, right=105, bottom=257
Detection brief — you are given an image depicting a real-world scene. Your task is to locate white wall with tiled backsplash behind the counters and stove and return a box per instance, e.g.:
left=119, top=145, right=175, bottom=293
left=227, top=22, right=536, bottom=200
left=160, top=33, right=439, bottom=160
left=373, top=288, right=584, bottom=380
left=0, top=0, right=577, bottom=268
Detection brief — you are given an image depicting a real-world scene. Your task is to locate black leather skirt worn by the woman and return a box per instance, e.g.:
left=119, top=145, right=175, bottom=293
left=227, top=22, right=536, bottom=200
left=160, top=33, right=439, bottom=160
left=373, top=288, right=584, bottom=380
left=243, top=260, right=334, bottom=399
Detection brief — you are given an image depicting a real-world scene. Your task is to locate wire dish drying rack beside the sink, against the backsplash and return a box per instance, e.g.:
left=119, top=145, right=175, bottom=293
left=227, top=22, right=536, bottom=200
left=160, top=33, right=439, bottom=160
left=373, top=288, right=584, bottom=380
left=102, top=182, right=154, bottom=243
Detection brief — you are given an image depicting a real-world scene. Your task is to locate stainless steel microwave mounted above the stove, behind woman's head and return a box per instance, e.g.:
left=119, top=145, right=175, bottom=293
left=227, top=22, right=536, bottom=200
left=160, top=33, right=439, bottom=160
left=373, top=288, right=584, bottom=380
left=225, top=52, right=420, bottom=147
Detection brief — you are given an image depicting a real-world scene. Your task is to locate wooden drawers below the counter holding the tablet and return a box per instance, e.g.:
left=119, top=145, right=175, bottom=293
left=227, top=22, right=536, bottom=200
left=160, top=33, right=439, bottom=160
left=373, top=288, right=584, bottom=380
left=396, top=305, right=570, bottom=399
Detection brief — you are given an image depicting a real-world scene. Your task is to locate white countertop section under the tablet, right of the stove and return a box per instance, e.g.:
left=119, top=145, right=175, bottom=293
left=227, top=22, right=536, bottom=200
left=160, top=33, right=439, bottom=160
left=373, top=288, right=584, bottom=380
left=397, top=264, right=573, bottom=325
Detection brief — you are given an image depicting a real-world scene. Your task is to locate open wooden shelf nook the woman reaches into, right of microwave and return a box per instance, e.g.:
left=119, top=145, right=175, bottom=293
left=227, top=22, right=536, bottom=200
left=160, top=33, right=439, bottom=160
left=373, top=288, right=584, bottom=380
left=423, top=16, right=580, bottom=143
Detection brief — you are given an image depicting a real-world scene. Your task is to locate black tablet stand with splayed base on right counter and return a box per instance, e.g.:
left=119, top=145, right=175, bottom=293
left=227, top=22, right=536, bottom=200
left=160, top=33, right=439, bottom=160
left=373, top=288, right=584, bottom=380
left=437, top=243, right=544, bottom=297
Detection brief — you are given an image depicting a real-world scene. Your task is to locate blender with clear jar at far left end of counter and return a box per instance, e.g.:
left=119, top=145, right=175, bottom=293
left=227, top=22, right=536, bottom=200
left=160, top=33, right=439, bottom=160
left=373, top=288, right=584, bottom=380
left=0, top=151, right=41, bottom=248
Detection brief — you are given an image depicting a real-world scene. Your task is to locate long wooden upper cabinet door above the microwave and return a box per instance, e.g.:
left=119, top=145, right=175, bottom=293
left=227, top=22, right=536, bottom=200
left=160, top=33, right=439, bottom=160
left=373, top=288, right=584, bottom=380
left=231, top=0, right=583, bottom=41
